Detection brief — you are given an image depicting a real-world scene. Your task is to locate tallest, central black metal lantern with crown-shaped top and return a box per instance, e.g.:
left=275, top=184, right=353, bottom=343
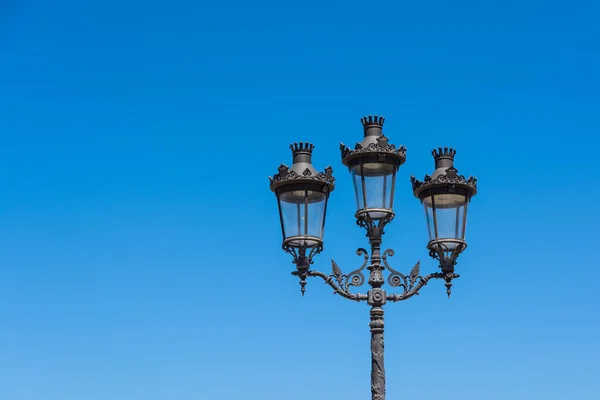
left=340, top=116, right=406, bottom=222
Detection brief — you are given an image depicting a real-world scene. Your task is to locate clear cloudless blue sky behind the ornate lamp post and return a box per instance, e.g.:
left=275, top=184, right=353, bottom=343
left=0, top=0, right=600, bottom=400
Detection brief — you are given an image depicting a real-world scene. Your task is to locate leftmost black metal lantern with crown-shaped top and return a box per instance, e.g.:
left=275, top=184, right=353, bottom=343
left=269, top=142, right=334, bottom=294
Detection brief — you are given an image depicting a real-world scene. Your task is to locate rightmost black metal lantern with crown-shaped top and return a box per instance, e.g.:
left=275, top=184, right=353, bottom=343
left=411, top=147, right=477, bottom=294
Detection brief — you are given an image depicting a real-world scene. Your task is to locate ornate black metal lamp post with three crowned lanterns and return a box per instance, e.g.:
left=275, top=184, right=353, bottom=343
left=270, top=116, right=477, bottom=400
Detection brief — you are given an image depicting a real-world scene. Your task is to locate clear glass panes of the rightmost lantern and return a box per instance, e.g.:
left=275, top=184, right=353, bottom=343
left=423, top=194, right=468, bottom=250
